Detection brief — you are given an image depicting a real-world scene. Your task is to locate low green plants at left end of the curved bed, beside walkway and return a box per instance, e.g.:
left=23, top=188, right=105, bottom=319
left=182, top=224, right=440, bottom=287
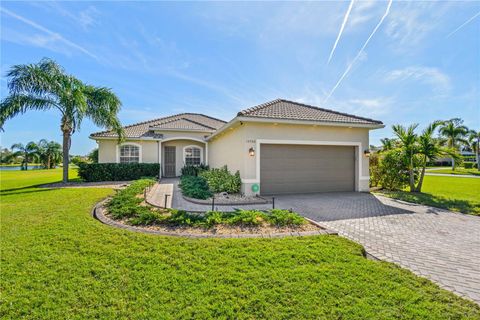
left=107, top=179, right=155, bottom=219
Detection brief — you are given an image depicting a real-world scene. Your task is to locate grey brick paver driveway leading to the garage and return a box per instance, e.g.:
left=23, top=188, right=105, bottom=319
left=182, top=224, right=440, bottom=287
left=276, top=193, right=480, bottom=303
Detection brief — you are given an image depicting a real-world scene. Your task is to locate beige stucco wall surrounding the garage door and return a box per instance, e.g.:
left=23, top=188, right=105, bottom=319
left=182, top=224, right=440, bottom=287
left=208, top=122, right=369, bottom=193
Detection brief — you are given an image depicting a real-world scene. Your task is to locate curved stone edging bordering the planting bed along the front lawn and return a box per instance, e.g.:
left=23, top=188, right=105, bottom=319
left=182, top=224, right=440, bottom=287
left=92, top=198, right=338, bottom=238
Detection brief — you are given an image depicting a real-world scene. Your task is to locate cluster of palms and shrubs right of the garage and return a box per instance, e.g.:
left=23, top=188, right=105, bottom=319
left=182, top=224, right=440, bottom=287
left=370, top=118, right=480, bottom=192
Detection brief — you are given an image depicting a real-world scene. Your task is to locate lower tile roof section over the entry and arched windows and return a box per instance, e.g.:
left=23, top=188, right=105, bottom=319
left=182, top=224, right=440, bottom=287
left=90, top=113, right=225, bottom=138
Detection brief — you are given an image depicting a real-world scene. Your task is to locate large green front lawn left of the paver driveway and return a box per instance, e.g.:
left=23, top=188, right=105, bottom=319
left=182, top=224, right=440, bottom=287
left=0, top=170, right=480, bottom=319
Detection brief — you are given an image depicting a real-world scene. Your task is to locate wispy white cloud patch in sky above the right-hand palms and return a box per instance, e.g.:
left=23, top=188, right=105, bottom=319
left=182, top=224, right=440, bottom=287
left=385, top=66, right=451, bottom=93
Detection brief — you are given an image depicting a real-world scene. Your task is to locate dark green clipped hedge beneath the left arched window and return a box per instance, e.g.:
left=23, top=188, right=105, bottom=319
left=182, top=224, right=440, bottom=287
left=78, top=163, right=160, bottom=182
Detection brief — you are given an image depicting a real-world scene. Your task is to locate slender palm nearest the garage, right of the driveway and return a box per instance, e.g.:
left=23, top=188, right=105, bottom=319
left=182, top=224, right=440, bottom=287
left=392, top=124, right=418, bottom=192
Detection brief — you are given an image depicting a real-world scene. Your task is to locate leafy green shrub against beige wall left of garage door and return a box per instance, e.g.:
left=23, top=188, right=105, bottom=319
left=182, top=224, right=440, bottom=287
left=199, top=166, right=242, bottom=193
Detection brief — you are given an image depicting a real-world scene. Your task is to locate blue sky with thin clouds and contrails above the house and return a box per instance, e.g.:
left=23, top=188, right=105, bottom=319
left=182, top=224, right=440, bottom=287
left=0, top=1, right=480, bottom=154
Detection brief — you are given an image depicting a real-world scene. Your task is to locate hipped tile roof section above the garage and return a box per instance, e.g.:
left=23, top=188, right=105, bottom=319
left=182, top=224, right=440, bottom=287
left=238, top=99, right=382, bottom=124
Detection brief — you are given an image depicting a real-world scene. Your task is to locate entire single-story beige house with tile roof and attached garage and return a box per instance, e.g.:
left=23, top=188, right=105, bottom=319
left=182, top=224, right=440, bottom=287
left=90, top=99, right=384, bottom=194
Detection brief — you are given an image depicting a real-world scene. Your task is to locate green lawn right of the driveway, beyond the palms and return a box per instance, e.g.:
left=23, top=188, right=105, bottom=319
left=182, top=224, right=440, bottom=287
left=381, top=175, right=480, bottom=215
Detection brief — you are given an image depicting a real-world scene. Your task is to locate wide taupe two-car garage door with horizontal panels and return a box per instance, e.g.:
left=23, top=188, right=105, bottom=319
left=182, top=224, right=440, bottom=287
left=260, top=144, right=355, bottom=194
